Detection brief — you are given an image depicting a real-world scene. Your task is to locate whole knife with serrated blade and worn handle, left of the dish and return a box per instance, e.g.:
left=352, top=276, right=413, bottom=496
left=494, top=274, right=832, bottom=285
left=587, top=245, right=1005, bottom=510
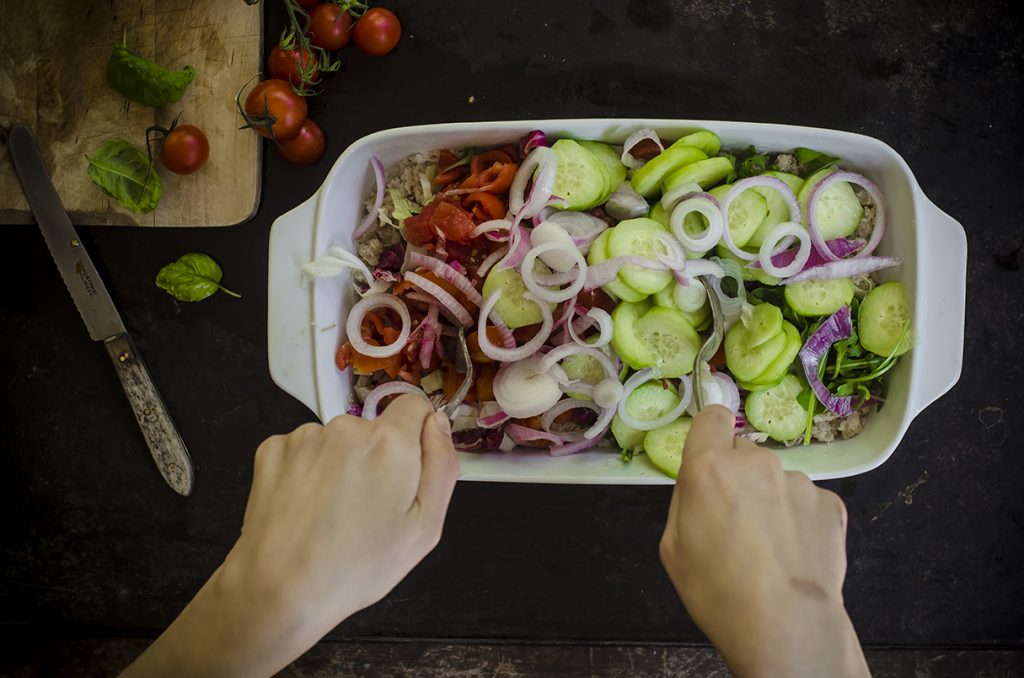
left=8, top=126, right=195, bottom=497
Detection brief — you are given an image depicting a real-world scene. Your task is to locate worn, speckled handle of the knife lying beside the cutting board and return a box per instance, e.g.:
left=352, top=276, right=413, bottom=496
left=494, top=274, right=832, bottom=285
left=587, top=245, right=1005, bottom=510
left=103, top=334, right=194, bottom=497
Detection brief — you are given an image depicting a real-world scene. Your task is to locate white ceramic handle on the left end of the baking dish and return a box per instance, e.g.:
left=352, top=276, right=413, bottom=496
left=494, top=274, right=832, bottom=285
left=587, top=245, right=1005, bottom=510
left=267, top=194, right=319, bottom=413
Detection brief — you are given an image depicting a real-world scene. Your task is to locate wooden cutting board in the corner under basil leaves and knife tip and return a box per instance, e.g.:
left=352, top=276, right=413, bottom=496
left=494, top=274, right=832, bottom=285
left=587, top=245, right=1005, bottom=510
left=0, top=0, right=262, bottom=226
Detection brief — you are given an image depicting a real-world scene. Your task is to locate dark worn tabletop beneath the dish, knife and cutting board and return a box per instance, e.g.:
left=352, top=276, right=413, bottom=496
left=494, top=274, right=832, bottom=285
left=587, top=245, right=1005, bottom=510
left=0, top=0, right=1024, bottom=675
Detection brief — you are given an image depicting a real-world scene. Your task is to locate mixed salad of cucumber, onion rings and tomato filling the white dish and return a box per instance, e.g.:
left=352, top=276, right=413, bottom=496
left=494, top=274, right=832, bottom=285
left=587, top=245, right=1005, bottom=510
left=303, top=129, right=913, bottom=476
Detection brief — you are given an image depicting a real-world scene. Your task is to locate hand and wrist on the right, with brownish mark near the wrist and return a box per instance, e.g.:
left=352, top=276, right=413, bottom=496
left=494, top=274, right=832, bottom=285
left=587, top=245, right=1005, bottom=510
left=660, top=406, right=867, bottom=676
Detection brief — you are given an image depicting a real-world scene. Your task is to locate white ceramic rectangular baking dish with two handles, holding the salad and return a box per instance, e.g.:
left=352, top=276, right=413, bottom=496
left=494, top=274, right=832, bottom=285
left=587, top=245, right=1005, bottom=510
left=267, top=119, right=967, bottom=484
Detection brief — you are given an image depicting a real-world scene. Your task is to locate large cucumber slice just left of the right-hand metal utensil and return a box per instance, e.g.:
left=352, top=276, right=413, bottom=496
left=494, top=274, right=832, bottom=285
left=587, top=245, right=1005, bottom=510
left=611, top=301, right=700, bottom=377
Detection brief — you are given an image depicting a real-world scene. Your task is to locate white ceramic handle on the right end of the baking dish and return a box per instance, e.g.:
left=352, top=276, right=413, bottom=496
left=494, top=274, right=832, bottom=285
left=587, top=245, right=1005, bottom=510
left=913, top=199, right=967, bottom=412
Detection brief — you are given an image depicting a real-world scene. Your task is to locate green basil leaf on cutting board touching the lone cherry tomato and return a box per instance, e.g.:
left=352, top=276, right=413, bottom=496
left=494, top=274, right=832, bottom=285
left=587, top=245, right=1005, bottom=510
left=88, top=139, right=164, bottom=214
